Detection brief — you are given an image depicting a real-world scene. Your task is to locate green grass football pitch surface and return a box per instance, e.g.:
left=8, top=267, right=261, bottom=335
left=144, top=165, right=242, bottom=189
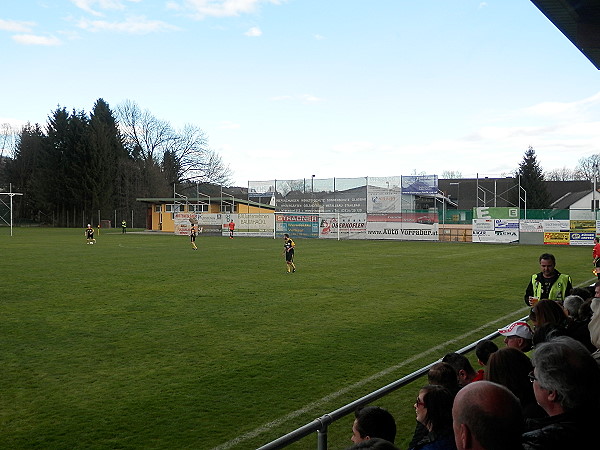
left=0, top=228, right=592, bottom=449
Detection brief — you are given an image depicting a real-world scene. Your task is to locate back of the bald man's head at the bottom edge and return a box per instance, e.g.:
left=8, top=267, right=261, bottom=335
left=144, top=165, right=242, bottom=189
left=452, top=380, right=524, bottom=450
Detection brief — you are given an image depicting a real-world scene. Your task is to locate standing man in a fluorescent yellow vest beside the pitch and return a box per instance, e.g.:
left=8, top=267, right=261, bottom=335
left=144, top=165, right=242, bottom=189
left=524, top=253, right=573, bottom=306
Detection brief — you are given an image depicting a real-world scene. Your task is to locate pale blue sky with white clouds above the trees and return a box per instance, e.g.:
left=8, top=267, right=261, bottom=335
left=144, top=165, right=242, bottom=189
left=0, top=0, right=600, bottom=186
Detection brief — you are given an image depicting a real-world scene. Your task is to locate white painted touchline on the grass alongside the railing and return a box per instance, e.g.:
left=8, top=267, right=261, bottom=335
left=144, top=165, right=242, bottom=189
left=212, top=306, right=527, bottom=450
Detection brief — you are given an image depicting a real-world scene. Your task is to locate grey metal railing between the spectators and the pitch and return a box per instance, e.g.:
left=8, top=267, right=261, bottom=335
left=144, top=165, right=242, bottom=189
left=257, top=316, right=528, bottom=450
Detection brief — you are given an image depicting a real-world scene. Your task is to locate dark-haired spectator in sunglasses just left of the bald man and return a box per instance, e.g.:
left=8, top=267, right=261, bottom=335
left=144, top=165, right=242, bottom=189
left=411, top=384, right=456, bottom=450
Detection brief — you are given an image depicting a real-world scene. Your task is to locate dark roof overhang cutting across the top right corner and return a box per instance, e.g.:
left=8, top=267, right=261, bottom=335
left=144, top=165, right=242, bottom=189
left=531, top=0, right=600, bottom=69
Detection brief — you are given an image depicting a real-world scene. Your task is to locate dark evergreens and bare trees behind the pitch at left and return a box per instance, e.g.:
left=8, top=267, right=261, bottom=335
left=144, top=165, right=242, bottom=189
left=0, top=98, right=231, bottom=226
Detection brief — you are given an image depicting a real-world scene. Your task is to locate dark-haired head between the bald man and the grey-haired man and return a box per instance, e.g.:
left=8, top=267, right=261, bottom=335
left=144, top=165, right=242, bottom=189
left=485, top=347, right=546, bottom=419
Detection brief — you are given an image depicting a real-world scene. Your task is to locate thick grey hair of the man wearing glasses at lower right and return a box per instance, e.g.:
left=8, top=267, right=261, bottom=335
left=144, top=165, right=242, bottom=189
left=532, top=336, right=600, bottom=411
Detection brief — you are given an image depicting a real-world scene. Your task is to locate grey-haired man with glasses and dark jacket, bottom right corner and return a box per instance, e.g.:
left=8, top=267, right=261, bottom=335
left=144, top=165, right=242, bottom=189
left=523, top=336, right=600, bottom=450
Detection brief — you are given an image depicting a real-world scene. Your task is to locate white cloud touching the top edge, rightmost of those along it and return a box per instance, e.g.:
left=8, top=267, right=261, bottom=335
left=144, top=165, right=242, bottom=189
left=173, top=0, right=287, bottom=19
